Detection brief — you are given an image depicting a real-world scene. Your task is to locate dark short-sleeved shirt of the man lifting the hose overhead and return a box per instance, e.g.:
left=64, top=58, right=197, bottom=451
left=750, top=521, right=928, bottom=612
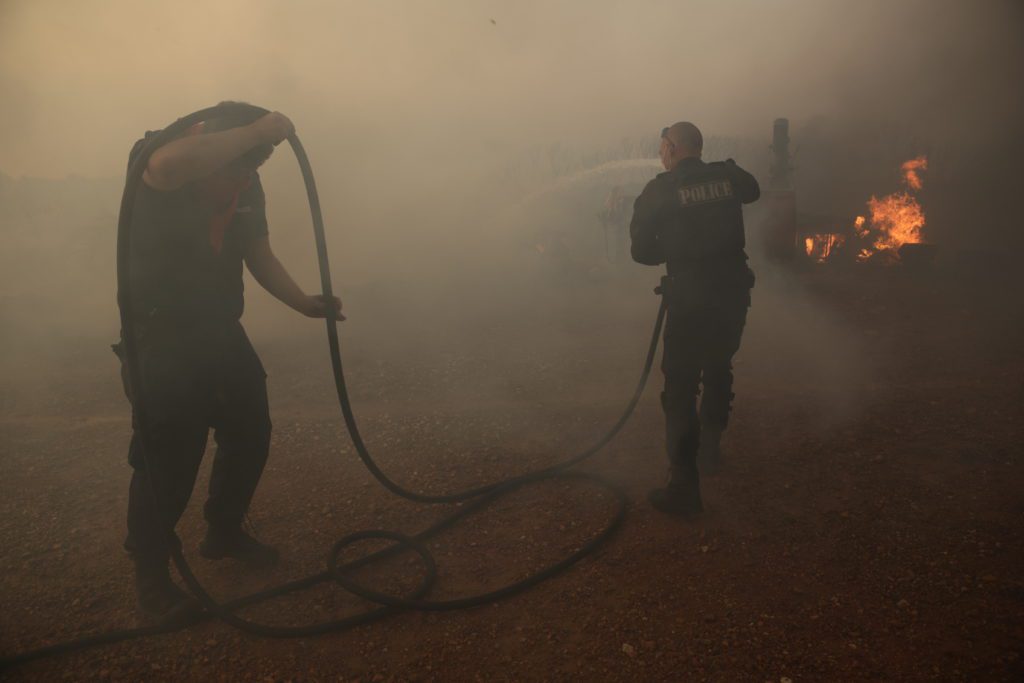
left=129, top=133, right=268, bottom=325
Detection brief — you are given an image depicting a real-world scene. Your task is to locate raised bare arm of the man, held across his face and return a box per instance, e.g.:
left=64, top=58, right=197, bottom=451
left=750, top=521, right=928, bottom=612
left=142, top=112, right=295, bottom=191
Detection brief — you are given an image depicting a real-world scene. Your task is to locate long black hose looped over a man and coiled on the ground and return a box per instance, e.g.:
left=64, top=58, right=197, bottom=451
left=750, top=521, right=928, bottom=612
left=0, top=103, right=666, bottom=669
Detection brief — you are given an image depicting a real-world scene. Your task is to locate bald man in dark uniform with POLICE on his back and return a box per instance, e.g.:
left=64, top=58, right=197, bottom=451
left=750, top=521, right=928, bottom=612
left=630, top=122, right=761, bottom=517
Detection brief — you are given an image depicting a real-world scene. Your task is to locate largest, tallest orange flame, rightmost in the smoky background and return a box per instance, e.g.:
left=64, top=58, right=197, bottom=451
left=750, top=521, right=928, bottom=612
left=853, top=157, right=928, bottom=261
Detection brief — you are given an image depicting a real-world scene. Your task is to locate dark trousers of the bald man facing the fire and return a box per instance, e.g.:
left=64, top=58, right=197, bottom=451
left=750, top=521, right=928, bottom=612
left=662, top=275, right=753, bottom=471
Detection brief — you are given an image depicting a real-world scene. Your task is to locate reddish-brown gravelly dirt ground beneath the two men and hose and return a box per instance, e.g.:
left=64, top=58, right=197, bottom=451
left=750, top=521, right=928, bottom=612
left=0, top=260, right=1024, bottom=682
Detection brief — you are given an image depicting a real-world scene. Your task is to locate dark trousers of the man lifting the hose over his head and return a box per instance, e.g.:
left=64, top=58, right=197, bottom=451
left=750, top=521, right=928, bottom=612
left=117, top=321, right=270, bottom=560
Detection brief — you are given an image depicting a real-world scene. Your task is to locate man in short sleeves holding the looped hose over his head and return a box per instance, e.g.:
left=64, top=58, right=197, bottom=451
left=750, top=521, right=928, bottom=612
left=115, top=102, right=341, bottom=622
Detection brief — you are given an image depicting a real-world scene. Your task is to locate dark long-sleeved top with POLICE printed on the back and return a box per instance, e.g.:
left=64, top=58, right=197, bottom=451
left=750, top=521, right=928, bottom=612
left=630, top=158, right=761, bottom=286
